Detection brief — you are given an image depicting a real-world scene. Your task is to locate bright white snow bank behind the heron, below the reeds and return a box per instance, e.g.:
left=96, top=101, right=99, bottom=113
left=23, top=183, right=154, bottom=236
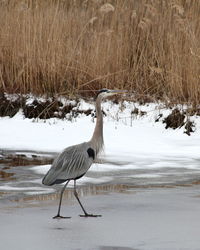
left=0, top=101, right=200, bottom=161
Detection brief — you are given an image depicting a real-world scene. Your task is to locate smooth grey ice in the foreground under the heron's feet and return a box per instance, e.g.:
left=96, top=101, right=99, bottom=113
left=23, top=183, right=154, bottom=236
left=0, top=186, right=200, bottom=250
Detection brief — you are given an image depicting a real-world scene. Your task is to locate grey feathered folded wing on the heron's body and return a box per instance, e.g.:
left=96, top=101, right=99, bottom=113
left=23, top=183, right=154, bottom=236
left=43, top=143, right=94, bottom=185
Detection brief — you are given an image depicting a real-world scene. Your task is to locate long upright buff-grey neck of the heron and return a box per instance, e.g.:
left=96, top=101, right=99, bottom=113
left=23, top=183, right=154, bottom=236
left=91, top=97, right=103, bottom=154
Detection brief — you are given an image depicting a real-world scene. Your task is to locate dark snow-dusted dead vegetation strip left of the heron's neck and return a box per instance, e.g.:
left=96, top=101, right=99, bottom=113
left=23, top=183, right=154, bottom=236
left=0, top=94, right=95, bottom=120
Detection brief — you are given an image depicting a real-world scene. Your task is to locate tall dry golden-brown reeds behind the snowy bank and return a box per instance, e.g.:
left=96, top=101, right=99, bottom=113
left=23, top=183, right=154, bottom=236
left=0, top=0, right=200, bottom=104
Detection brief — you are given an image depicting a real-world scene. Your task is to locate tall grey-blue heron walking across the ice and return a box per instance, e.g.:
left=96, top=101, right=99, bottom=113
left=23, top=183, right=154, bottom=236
left=42, top=89, right=127, bottom=219
